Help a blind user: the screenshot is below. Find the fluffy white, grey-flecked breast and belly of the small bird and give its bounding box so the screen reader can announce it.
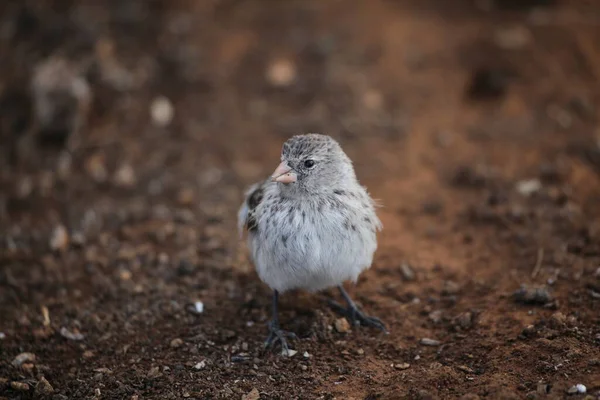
[249,188,379,292]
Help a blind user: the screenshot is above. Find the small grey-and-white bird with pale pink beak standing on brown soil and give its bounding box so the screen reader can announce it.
[238,133,388,354]
